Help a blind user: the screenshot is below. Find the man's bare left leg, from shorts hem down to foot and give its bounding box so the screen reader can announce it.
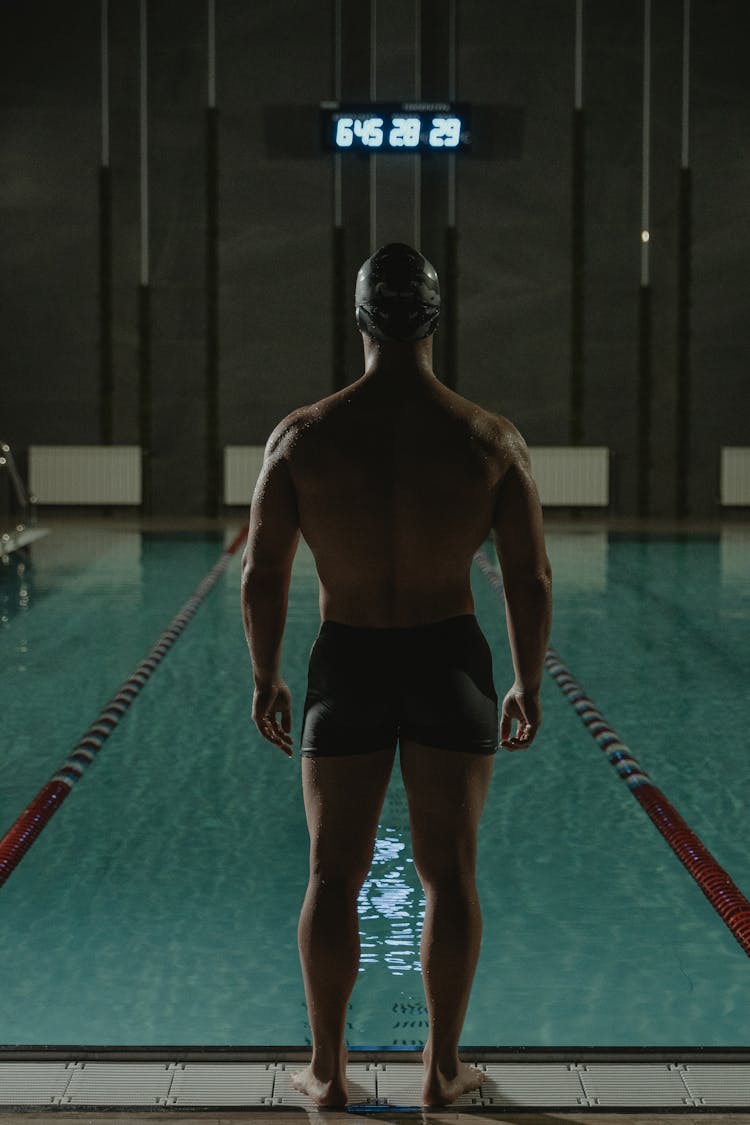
[292,749,396,1106]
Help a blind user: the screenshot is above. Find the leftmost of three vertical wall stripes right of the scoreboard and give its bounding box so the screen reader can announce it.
[568,0,586,446]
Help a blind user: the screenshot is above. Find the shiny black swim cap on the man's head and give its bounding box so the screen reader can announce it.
[354,242,440,343]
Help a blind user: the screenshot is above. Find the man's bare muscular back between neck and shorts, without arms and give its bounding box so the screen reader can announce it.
[269,372,523,627]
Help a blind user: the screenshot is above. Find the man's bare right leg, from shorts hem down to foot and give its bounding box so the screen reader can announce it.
[401,743,494,1106]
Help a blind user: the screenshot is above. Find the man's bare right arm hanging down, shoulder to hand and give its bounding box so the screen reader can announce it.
[493,431,552,750]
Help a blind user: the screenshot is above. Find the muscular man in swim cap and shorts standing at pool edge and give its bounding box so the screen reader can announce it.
[242,243,551,1107]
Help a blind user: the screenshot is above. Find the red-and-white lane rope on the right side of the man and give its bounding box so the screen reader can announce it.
[475,548,750,956]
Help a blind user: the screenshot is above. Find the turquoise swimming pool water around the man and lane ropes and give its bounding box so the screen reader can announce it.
[0,528,750,1046]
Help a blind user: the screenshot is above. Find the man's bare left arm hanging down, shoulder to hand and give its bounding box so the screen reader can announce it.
[242,438,299,757]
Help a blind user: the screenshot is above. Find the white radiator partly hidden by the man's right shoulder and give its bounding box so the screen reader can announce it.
[528,446,609,507]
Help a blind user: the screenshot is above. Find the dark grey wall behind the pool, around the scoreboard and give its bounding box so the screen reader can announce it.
[0,0,750,515]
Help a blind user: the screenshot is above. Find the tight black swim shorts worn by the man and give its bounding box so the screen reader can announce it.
[301,613,498,757]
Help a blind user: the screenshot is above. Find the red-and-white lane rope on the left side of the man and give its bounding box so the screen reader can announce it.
[0,527,247,887]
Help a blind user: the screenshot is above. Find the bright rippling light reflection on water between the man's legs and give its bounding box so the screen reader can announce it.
[359,826,424,977]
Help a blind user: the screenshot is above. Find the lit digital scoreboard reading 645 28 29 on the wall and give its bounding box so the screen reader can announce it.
[320,101,471,153]
